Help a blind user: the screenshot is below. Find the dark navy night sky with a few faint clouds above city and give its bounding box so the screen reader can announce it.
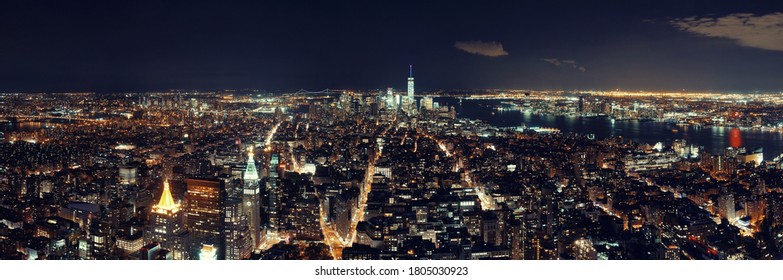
[0,0,783,92]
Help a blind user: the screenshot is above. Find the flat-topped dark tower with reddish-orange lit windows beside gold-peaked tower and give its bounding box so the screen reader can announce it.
[185,179,226,259]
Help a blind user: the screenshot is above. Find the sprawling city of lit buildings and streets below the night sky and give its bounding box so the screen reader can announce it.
[0,65,783,260]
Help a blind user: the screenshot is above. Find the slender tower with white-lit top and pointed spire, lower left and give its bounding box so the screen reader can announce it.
[242,147,261,248]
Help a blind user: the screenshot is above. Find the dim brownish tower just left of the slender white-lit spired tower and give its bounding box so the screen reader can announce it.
[224,198,254,260]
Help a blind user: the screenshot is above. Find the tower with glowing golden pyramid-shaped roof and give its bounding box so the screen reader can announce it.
[144,180,190,260]
